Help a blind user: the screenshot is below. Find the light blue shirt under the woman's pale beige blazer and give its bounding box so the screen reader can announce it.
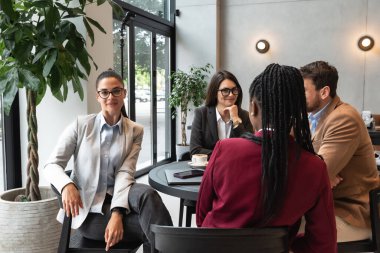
[90,113,123,213]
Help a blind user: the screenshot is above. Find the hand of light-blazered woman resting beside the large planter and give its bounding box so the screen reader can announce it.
[62,183,83,217]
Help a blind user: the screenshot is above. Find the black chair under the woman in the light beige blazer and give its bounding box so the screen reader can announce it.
[51,171,141,253]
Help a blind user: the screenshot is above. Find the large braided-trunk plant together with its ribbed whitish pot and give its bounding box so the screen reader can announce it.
[0,0,121,252]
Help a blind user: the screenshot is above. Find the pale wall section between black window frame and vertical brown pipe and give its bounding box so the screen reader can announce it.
[176,0,220,143]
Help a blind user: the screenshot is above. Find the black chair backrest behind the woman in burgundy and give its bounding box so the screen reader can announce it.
[151,225,289,253]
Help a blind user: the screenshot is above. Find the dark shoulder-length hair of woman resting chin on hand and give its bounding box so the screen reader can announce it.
[205,70,243,108]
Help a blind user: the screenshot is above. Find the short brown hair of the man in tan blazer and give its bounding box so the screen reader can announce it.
[300,61,339,98]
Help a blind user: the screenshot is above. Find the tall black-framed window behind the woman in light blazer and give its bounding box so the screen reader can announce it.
[113,1,175,176]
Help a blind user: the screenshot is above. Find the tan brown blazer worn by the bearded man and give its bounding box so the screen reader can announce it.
[312,96,379,228]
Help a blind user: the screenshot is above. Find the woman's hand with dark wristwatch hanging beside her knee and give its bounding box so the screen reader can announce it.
[104,212,124,251]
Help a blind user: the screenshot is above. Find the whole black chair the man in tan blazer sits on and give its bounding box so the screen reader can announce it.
[338,188,380,253]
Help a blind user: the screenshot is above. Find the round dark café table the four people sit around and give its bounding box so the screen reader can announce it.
[149,161,199,227]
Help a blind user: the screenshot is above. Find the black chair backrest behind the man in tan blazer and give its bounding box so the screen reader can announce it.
[369,187,380,251]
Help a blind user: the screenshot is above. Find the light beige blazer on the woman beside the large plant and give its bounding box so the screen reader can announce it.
[42,114,143,229]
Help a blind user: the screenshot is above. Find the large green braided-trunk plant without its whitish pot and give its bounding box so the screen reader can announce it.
[0,0,121,200]
